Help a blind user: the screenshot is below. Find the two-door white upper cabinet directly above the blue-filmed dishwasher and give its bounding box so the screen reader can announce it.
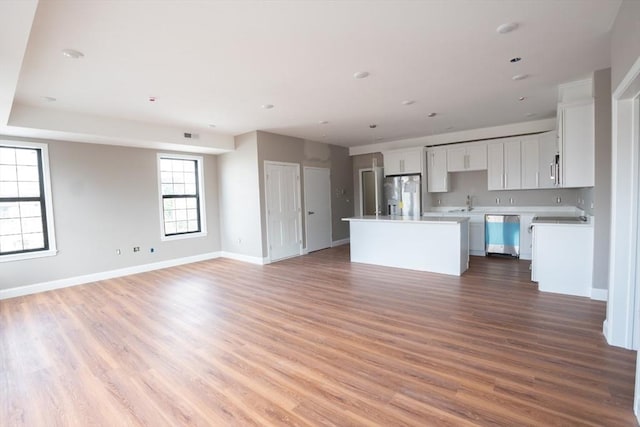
[487,139,522,190]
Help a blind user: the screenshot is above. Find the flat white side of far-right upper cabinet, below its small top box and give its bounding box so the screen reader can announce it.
[561,102,595,187]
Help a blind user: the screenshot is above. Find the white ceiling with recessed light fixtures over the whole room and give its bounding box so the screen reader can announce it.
[0,0,620,153]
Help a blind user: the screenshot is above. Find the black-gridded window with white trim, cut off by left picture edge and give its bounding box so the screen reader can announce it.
[0,141,56,261]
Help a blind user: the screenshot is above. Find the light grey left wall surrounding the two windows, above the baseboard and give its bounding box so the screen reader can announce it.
[0,138,220,290]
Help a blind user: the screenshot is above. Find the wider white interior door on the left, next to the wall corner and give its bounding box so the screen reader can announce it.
[264,162,302,261]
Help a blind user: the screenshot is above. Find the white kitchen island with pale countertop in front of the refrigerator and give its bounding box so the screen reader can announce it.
[343,215,469,276]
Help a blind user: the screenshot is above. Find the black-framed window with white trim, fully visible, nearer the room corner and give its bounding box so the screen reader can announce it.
[158,154,206,240]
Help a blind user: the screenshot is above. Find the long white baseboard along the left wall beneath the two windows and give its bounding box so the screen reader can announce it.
[0,252,220,300]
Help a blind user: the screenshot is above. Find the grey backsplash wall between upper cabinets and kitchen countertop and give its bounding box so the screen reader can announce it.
[423,171,593,213]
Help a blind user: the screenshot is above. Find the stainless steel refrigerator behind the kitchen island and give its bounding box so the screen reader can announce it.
[384,174,422,217]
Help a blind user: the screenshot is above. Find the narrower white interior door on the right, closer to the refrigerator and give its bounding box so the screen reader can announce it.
[304,167,331,252]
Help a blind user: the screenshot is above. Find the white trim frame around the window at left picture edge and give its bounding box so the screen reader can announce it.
[0,138,58,262]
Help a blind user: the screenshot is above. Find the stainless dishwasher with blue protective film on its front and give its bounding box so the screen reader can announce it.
[484,214,520,258]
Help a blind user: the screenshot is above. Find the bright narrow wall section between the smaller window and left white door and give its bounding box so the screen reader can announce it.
[218,132,266,261]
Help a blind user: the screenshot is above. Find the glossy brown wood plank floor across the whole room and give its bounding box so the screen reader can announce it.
[0,246,636,426]
